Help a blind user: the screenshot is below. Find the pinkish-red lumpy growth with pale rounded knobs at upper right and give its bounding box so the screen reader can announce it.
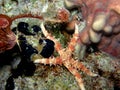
[65,0,120,57]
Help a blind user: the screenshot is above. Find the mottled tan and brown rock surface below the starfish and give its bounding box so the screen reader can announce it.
[0,53,120,90]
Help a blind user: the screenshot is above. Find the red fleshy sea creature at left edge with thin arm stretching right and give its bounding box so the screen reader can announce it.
[0,14,43,53]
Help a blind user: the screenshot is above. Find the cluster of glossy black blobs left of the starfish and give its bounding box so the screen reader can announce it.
[3,22,54,90]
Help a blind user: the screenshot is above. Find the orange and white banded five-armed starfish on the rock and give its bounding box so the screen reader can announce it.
[34,23,97,90]
